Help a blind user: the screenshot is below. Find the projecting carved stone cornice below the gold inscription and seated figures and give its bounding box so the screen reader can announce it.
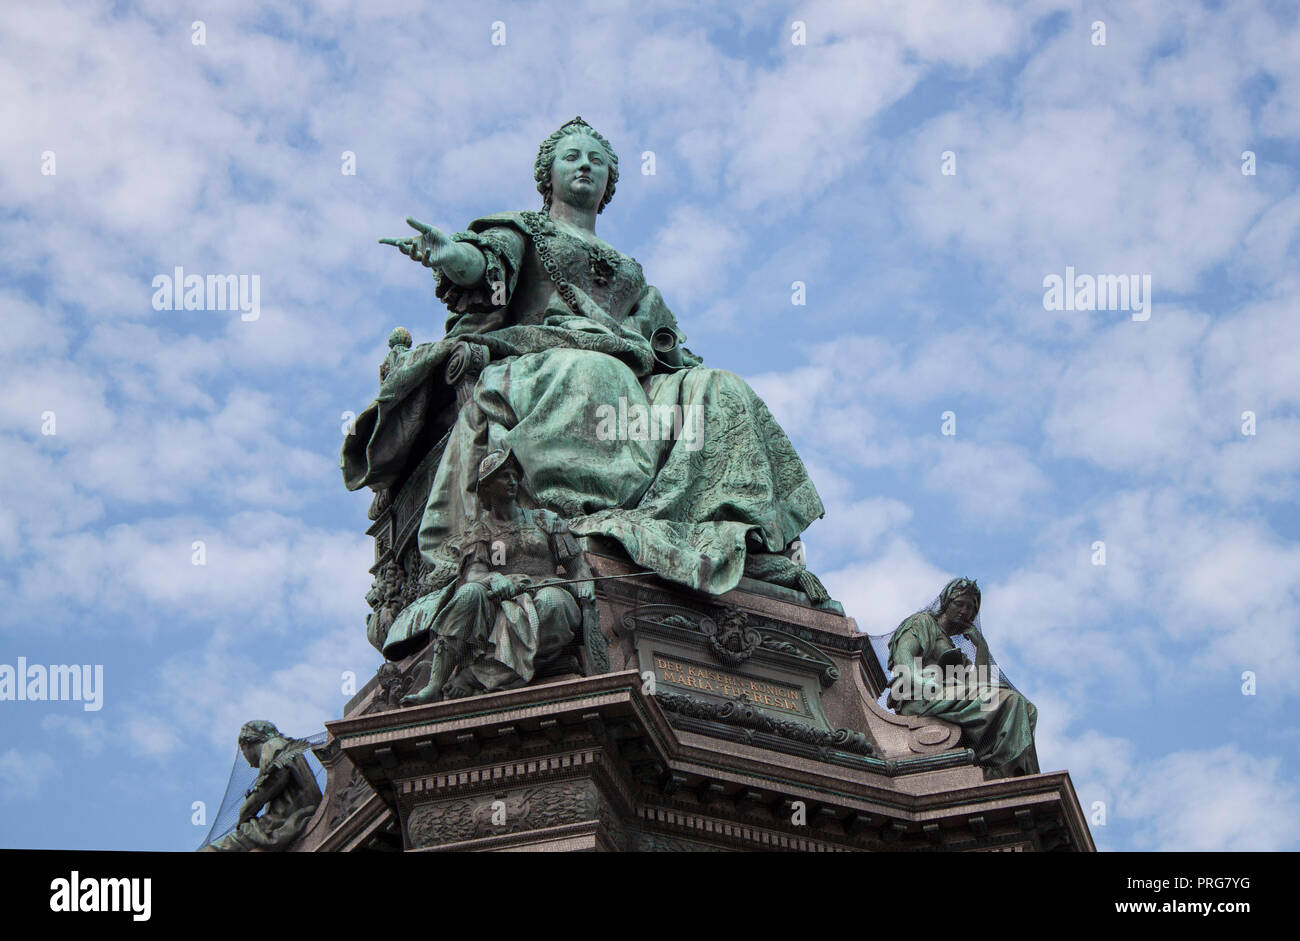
[309,671,1092,851]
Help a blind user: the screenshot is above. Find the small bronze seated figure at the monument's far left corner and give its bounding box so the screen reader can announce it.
[202,719,321,853]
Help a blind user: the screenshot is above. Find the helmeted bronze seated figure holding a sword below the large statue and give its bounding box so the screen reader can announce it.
[382,451,605,706]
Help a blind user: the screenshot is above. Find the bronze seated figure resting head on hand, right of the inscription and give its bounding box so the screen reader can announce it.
[889,578,1039,777]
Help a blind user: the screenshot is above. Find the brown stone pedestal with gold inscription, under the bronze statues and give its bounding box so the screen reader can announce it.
[289,546,1095,851]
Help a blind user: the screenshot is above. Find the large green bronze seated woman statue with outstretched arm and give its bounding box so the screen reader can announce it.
[342,118,827,602]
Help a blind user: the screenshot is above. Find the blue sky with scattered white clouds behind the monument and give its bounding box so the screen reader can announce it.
[0,0,1300,850]
